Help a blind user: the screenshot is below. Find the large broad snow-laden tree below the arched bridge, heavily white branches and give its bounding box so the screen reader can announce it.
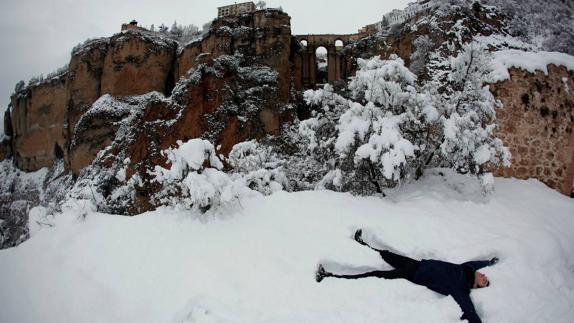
[300,56,438,194]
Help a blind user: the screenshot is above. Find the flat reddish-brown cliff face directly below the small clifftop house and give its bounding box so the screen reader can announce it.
[101,31,177,96]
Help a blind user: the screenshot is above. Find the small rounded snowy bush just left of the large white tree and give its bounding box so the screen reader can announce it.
[228,140,289,195]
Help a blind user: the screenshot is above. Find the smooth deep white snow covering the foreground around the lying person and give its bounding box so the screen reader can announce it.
[0,170,574,323]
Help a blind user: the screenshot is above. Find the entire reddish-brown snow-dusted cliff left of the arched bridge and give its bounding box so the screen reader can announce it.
[0,10,298,247]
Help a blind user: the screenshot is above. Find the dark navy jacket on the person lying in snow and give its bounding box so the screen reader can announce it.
[413,260,490,323]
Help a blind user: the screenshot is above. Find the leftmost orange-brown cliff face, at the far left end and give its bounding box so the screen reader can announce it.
[11,74,68,171]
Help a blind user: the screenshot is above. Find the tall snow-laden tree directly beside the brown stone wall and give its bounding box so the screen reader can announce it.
[431,43,510,191]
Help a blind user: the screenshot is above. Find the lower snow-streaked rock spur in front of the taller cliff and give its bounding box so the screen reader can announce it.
[80,54,294,214]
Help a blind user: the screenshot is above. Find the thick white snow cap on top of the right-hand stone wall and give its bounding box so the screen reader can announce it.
[492,49,574,83]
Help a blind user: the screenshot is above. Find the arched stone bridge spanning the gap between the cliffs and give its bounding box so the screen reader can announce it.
[295,35,358,88]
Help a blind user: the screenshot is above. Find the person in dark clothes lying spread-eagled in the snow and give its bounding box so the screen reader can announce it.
[316,229,498,323]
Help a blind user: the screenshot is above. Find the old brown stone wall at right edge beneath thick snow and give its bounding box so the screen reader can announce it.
[491,65,574,195]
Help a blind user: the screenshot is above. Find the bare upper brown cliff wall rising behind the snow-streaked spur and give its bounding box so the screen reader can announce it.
[7,10,300,175]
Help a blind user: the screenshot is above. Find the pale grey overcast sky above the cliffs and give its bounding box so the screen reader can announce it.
[0,0,410,133]
